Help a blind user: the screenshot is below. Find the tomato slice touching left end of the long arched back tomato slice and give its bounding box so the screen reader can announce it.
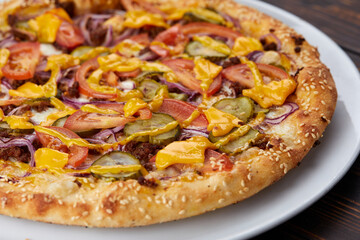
[150,24,189,57]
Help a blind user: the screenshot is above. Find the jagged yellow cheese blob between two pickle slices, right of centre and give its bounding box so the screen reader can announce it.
[204,107,241,137]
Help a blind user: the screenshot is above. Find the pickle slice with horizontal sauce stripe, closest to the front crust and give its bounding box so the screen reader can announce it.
[90,151,140,180]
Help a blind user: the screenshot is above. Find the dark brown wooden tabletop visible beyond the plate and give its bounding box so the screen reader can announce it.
[254,0,360,240]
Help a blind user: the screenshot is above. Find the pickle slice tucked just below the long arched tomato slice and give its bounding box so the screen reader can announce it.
[185,41,227,61]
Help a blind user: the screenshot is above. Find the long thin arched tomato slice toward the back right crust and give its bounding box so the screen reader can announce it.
[181,22,242,41]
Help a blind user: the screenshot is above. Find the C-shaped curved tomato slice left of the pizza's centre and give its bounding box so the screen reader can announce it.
[75,58,117,99]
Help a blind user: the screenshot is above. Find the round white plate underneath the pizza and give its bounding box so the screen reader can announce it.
[0,0,360,240]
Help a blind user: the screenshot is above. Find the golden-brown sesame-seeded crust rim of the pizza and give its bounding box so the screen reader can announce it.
[0,0,337,227]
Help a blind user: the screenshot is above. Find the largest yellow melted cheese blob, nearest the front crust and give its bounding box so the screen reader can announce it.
[155,136,215,170]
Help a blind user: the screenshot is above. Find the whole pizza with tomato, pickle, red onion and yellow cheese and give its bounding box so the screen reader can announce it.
[0,0,337,227]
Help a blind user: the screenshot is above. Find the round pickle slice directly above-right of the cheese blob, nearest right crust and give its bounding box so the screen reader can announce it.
[213,97,255,123]
